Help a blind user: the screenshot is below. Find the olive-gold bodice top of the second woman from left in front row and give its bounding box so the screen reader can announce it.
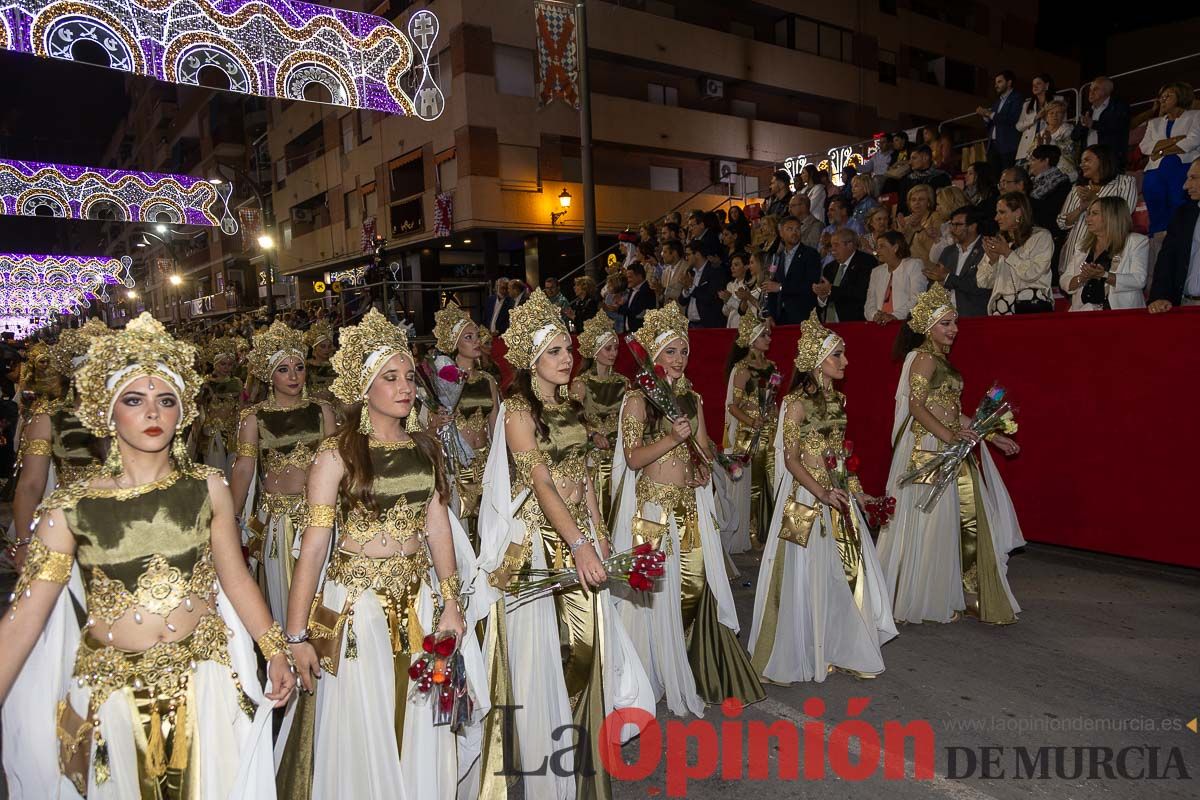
[320,437,437,545]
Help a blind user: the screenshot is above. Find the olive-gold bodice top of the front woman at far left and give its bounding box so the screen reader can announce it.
[44,467,216,625]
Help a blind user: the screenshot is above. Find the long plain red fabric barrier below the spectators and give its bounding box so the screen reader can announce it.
[494,308,1200,567]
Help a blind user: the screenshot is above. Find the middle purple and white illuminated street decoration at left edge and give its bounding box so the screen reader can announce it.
[0,158,238,235]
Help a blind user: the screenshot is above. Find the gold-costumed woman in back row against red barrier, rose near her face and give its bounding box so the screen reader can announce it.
[725,311,782,553]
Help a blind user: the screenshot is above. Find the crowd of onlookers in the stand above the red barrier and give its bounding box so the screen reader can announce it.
[481,72,1200,333]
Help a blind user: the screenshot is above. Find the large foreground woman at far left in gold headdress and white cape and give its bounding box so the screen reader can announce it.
[0,314,295,800]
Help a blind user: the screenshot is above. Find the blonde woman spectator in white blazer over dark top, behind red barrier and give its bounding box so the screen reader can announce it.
[1058,197,1150,311]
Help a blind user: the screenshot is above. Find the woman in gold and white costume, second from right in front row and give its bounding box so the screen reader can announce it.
[750,312,896,684]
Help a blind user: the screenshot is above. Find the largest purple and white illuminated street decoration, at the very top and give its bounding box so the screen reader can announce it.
[0,0,445,119]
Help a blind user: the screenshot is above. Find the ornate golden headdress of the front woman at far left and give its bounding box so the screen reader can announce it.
[76,312,200,437]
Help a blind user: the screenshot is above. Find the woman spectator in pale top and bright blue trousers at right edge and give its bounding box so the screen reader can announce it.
[1130,83,1200,236]
